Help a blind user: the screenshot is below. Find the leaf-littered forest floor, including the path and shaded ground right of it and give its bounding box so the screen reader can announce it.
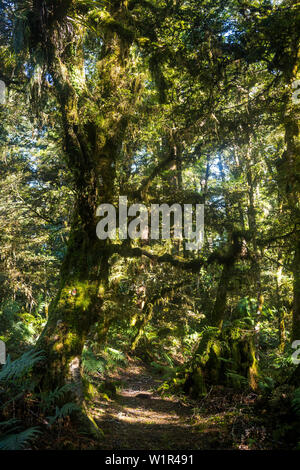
[91,361,270,450]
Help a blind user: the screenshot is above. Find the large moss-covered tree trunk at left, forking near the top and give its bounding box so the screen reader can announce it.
[28,4,130,395]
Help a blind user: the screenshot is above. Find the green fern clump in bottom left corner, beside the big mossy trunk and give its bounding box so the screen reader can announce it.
[0,350,80,450]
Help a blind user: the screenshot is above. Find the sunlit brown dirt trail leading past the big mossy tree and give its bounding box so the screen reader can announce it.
[92,363,244,450]
